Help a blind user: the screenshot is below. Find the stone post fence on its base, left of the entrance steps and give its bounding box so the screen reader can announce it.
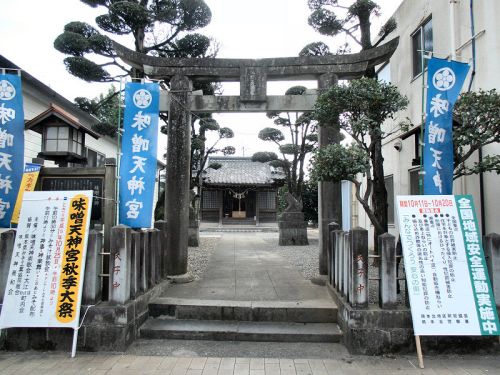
[0,221,169,351]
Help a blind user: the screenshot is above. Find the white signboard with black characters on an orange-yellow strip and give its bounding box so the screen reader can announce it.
[0,190,92,329]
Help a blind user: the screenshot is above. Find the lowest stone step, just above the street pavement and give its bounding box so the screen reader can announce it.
[139,318,342,342]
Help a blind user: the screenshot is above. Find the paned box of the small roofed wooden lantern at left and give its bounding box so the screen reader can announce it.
[44,126,83,155]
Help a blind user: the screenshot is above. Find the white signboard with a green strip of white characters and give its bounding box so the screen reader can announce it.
[397,195,500,336]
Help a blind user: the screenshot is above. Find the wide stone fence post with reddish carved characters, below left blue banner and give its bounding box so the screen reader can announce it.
[109,225,132,304]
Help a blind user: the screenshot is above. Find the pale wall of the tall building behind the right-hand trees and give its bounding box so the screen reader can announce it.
[358,0,500,245]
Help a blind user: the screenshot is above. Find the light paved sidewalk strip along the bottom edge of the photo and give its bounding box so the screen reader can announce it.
[0,352,500,375]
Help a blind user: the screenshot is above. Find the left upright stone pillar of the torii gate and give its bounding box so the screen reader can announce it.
[165,75,192,276]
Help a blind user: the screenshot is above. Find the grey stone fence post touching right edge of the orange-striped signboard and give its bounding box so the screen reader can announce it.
[82,229,103,305]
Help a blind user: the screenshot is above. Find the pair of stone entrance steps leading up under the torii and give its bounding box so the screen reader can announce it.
[140,298,342,342]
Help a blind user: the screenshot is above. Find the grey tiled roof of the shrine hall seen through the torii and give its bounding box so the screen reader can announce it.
[203,157,285,186]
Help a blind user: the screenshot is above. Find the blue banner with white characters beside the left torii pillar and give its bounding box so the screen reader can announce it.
[119,83,160,228]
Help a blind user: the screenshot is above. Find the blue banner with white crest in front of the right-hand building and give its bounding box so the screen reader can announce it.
[423,58,469,195]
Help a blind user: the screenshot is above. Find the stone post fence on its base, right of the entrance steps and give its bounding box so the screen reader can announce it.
[327,223,500,354]
